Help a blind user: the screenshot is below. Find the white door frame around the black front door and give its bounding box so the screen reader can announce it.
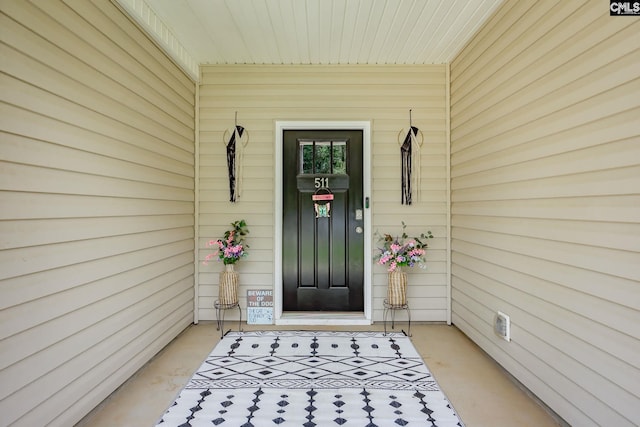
[273,121,373,325]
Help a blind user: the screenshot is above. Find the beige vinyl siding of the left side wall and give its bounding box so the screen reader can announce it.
[0,0,195,426]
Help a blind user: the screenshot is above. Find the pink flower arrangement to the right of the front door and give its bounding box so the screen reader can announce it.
[376,222,433,271]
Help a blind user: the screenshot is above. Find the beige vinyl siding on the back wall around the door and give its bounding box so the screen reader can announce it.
[199,65,447,321]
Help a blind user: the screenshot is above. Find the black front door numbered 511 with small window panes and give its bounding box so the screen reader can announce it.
[282,130,364,311]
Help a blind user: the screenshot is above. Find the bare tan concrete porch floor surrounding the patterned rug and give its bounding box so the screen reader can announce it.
[77,321,560,427]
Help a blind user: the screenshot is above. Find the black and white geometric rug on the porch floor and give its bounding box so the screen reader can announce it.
[157,331,463,427]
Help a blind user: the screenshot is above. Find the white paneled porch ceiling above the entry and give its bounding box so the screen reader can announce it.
[115,0,503,79]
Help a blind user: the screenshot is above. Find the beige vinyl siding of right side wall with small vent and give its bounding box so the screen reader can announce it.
[451,1,640,426]
